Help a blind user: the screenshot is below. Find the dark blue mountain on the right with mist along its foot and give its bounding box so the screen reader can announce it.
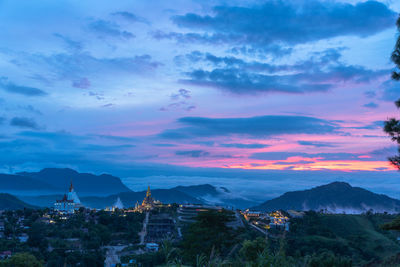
[252,182,400,213]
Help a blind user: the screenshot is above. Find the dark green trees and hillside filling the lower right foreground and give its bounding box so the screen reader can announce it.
[123,211,400,267]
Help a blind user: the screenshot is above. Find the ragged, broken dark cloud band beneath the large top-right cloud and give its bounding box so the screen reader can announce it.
[175,49,388,95]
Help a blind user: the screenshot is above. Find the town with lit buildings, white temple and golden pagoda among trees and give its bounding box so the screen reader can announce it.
[0,182,293,266]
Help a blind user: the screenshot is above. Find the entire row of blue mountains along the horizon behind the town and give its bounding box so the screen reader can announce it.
[0,168,400,213]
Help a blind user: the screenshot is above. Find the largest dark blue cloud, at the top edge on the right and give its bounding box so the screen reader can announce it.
[166,0,396,48]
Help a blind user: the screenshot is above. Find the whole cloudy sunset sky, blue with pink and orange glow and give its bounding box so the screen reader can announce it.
[0,0,400,200]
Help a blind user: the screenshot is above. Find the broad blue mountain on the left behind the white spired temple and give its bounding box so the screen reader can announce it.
[16,168,131,195]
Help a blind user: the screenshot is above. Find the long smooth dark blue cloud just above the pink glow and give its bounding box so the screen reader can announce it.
[160,115,339,139]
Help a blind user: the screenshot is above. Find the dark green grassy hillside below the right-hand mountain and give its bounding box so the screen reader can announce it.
[287,212,400,266]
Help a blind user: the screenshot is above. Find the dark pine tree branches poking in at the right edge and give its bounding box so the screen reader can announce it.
[384,16,400,170]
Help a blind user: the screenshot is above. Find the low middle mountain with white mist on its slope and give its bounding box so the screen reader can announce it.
[172,184,257,209]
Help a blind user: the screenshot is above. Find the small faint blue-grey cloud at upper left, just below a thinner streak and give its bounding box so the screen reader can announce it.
[89,19,135,39]
